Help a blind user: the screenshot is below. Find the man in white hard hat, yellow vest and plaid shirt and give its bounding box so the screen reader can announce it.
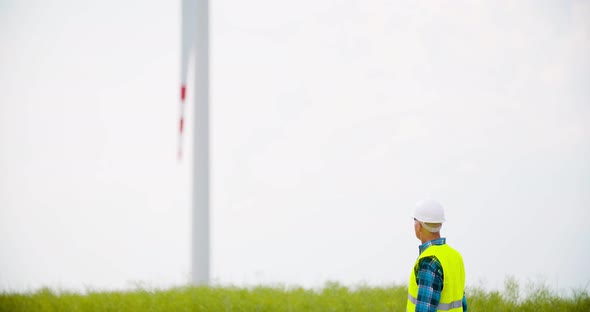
[406,200,467,312]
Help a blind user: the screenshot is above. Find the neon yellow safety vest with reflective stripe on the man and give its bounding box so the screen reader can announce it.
[406,244,465,312]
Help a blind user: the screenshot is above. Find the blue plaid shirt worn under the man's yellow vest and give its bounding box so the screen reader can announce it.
[414,237,467,312]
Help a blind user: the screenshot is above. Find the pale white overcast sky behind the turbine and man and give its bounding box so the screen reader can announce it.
[0,0,590,290]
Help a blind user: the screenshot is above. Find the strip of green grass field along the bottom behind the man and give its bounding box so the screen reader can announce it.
[0,280,590,312]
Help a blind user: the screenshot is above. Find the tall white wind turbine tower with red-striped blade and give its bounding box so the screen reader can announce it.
[178,0,210,285]
